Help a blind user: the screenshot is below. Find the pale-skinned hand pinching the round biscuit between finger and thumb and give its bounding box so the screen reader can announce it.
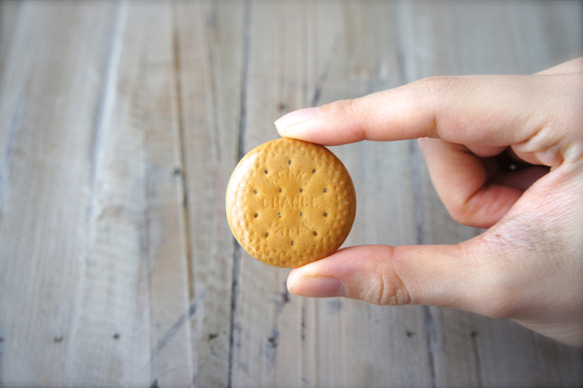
[276,57,583,347]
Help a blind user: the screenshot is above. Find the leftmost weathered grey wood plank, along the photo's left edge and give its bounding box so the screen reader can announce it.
[0,2,130,385]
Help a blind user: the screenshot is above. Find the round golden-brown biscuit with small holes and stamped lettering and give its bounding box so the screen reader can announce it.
[226,138,356,267]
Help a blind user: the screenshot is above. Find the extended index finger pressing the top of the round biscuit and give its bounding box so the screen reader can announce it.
[275,75,560,146]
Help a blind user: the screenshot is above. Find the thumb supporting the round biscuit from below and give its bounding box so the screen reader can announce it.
[287,242,505,317]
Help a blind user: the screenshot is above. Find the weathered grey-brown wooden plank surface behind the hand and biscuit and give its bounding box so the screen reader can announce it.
[0,0,583,387]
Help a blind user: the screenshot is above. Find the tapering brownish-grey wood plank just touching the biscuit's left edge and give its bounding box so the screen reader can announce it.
[173,1,247,387]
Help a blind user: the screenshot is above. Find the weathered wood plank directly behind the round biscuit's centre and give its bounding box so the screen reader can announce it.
[231,1,311,386]
